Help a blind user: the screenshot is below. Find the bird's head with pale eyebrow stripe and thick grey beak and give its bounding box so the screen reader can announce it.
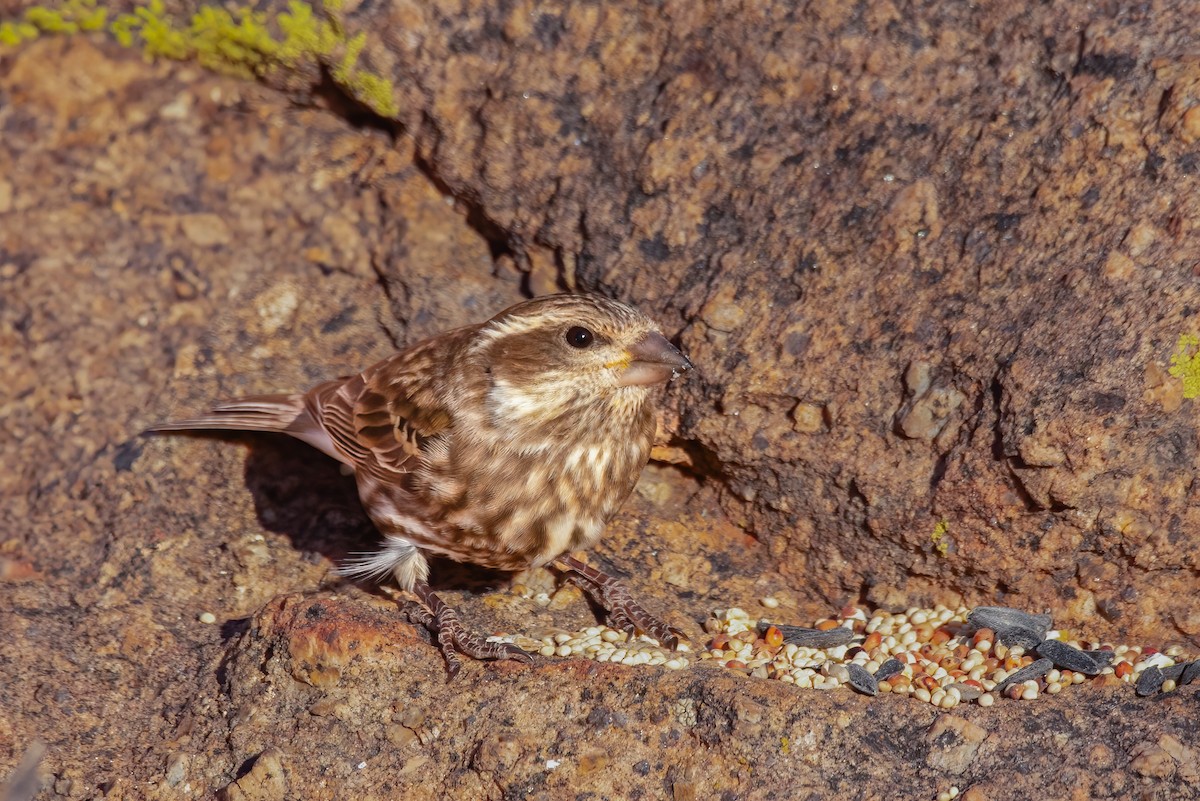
[473,295,692,428]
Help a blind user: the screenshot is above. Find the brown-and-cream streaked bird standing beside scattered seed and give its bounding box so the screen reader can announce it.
[148,293,694,679]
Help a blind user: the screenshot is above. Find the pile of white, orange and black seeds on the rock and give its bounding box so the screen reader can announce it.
[493,598,1200,709]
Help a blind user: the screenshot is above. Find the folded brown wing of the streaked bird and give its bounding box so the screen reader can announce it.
[305,326,479,481]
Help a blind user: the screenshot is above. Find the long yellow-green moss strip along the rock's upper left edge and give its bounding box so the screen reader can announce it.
[0,0,400,116]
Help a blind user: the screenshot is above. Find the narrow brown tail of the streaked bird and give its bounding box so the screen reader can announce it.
[146,395,349,464]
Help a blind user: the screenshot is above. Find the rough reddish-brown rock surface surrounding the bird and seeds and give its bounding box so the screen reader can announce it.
[0,0,1200,801]
